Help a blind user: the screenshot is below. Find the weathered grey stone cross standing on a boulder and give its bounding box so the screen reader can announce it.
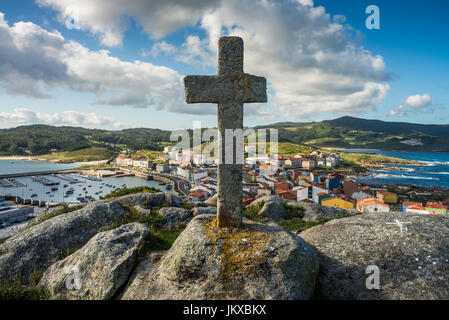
[184,37,267,227]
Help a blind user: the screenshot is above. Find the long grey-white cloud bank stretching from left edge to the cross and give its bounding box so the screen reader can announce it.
[0,13,194,112]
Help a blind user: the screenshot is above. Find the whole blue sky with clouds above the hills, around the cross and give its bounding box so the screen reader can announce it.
[0,0,449,129]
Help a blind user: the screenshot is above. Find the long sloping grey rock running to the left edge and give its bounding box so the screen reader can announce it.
[0,201,126,283]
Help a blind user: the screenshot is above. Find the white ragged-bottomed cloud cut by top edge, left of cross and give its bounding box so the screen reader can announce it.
[36,0,220,46]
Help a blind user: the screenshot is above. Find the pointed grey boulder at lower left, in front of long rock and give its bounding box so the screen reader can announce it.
[39,223,150,300]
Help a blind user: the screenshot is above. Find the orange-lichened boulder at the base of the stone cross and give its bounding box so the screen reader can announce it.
[122,215,318,300]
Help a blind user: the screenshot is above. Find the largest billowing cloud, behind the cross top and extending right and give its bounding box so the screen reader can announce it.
[177,0,390,119]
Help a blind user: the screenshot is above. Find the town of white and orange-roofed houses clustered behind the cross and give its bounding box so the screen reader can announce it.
[116,146,449,214]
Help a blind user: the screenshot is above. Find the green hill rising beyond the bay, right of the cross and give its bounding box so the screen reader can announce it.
[260,117,449,152]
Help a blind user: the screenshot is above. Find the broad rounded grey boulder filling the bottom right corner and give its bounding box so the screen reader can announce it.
[299,213,449,299]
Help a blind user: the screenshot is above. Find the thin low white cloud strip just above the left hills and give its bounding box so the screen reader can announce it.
[0,108,126,129]
